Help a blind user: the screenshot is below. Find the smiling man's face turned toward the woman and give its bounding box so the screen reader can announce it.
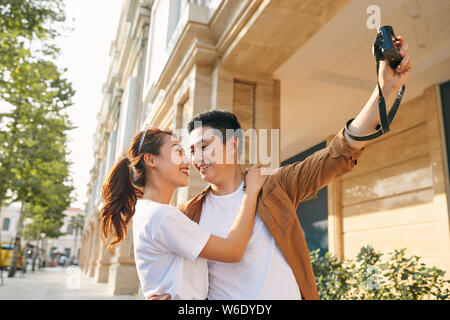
[190,126,236,183]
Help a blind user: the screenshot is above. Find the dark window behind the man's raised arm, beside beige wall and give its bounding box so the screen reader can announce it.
[281,142,328,255]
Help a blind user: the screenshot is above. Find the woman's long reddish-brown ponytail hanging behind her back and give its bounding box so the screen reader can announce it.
[100,158,142,251]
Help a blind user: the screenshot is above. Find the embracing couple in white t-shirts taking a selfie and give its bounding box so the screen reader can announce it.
[101,37,411,300]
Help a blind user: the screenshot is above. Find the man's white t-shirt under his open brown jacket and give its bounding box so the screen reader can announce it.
[200,183,301,300]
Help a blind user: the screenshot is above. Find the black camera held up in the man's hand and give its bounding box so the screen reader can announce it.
[373,26,402,70]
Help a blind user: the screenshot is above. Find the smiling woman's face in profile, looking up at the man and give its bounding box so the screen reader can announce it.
[154,135,190,188]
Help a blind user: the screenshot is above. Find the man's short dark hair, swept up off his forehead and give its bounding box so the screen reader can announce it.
[187,110,242,156]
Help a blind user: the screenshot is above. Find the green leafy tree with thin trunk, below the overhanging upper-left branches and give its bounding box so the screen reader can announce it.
[6,74,73,276]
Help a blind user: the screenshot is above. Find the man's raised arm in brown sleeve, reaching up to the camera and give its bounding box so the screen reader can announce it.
[271,37,412,206]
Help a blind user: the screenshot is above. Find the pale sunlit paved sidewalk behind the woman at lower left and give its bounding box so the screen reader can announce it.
[0,266,143,300]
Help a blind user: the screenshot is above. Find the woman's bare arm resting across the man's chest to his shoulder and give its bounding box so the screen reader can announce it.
[199,166,267,262]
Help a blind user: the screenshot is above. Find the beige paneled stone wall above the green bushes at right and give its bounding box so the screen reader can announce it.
[330,86,450,271]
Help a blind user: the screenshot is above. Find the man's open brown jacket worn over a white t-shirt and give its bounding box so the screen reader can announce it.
[179,128,364,300]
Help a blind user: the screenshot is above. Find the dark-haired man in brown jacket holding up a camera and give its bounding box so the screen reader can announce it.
[154,37,412,300]
